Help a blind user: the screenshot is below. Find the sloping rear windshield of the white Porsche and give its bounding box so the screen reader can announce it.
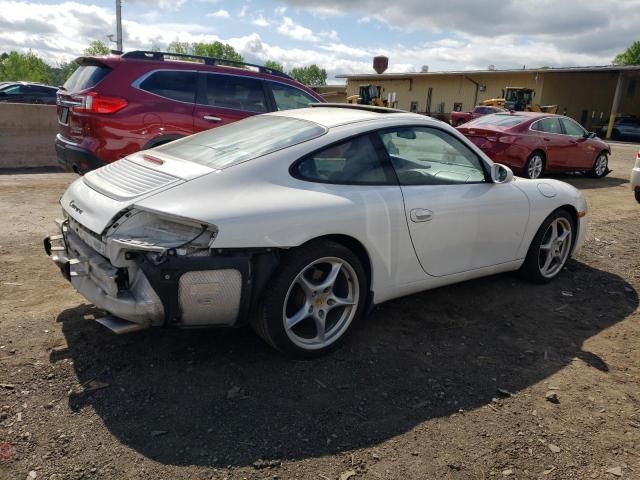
[155,115,326,170]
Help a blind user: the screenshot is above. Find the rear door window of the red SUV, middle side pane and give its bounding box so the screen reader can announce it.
[204,73,267,113]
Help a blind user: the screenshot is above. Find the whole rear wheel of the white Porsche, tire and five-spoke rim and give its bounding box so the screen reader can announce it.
[254,241,368,358]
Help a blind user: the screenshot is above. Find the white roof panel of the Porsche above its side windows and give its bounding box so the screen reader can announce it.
[265,103,439,128]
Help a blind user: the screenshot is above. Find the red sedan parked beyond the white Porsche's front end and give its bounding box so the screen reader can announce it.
[458,112,611,178]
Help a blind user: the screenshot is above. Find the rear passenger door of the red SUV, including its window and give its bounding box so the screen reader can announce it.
[193,72,268,132]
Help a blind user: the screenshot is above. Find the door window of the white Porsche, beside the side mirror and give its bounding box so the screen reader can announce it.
[380,127,486,185]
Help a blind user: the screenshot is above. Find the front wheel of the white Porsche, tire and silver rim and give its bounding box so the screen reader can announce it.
[520,210,575,283]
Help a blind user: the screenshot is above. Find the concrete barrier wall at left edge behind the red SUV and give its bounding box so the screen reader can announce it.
[0,103,58,169]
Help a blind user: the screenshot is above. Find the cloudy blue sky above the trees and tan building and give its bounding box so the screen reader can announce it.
[0,0,640,81]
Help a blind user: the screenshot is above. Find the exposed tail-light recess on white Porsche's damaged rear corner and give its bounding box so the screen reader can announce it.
[106,210,217,252]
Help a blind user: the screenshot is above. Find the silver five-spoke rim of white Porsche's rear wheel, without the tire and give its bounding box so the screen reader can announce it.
[282,257,360,350]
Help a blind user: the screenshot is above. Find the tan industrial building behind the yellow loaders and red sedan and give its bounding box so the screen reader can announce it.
[338,65,640,137]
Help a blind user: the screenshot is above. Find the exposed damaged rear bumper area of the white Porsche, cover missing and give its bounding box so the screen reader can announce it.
[44,220,276,327]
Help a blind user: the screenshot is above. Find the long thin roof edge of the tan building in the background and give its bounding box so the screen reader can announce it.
[336,65,640,79]
